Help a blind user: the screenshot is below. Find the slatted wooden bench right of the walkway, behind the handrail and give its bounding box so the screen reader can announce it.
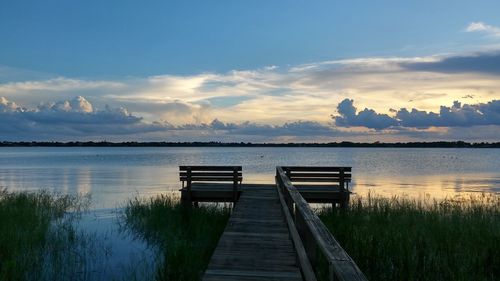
[281,166,352,206]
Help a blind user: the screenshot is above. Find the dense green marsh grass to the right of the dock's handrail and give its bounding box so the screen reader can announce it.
[318,194,500,280]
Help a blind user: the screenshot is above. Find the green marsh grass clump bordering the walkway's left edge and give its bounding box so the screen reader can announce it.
[124,194,230,280]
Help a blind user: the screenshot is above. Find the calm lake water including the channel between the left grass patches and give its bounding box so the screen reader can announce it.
[0,147,500,280]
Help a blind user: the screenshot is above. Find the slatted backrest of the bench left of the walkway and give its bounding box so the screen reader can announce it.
[179,166,243,183]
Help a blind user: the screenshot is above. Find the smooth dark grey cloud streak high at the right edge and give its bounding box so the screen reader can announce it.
[400,52,500,74]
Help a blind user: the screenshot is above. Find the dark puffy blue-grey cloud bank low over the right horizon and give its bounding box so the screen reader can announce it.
[333,99,500,130]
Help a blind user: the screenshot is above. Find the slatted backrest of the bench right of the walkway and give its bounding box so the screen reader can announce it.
[281,166,351,189]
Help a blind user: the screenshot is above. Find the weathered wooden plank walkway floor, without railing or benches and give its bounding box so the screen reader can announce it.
[203,184,302,281]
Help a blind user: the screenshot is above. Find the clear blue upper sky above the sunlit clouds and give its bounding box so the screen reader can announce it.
[0,0,500,78]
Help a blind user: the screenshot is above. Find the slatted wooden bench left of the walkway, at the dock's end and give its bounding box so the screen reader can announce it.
[179,166,243,205]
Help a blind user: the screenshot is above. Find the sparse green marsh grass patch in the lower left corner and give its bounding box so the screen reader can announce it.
[0,189,93,280]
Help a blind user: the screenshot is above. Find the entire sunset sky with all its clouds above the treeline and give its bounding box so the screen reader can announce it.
[0,0,500,142]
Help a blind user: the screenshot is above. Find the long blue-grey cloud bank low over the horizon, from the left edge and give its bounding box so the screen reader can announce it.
[0,96,344,139]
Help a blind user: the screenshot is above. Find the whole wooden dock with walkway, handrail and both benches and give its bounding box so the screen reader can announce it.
[179,166,367,281]
